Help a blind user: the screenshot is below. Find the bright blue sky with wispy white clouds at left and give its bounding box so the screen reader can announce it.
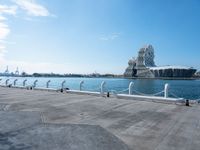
[0,0,200,74]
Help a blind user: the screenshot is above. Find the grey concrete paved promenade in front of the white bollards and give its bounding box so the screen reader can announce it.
[0,87,200,150]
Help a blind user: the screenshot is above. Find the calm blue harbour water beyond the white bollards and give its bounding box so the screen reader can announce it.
[0,77,200,100]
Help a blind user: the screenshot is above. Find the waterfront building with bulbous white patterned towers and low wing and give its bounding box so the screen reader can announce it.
[124,45,196,78]
